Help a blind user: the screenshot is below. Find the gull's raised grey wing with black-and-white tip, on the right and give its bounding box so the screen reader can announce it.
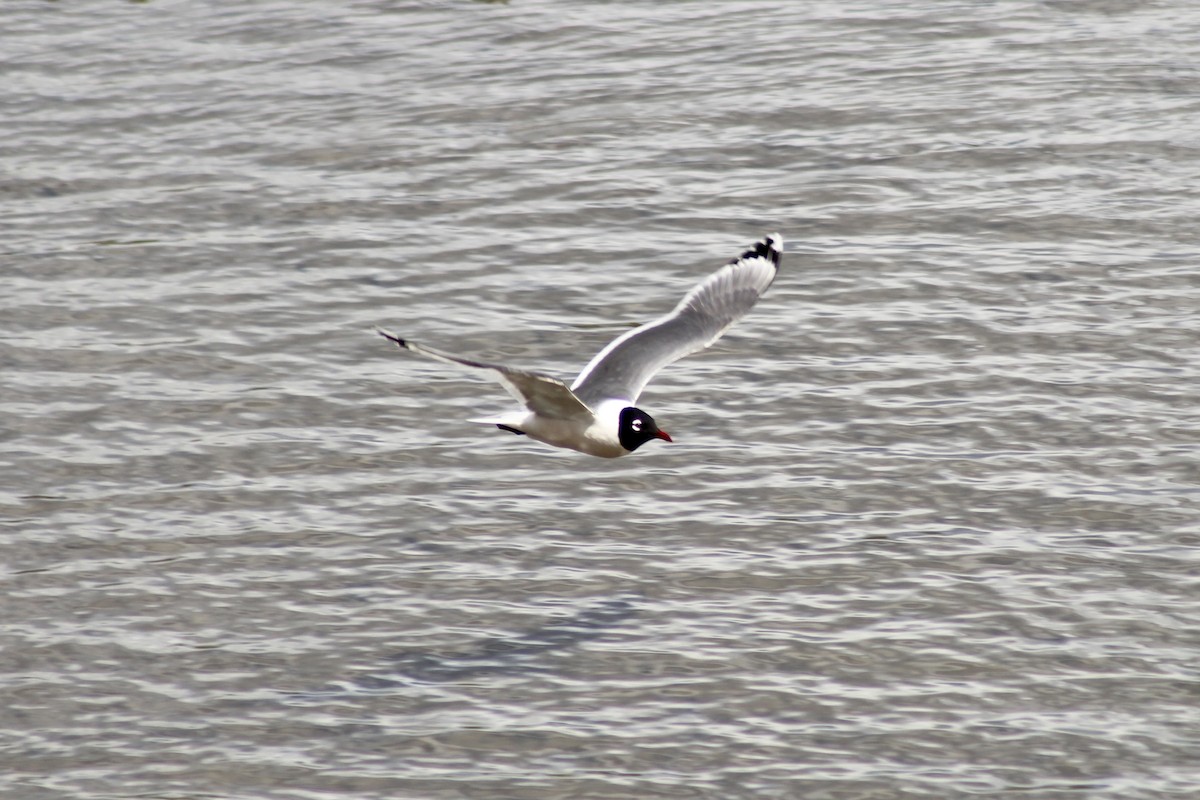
[571,234,784,407]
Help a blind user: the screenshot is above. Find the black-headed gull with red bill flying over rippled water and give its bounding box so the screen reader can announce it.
[377,234,784,458]
